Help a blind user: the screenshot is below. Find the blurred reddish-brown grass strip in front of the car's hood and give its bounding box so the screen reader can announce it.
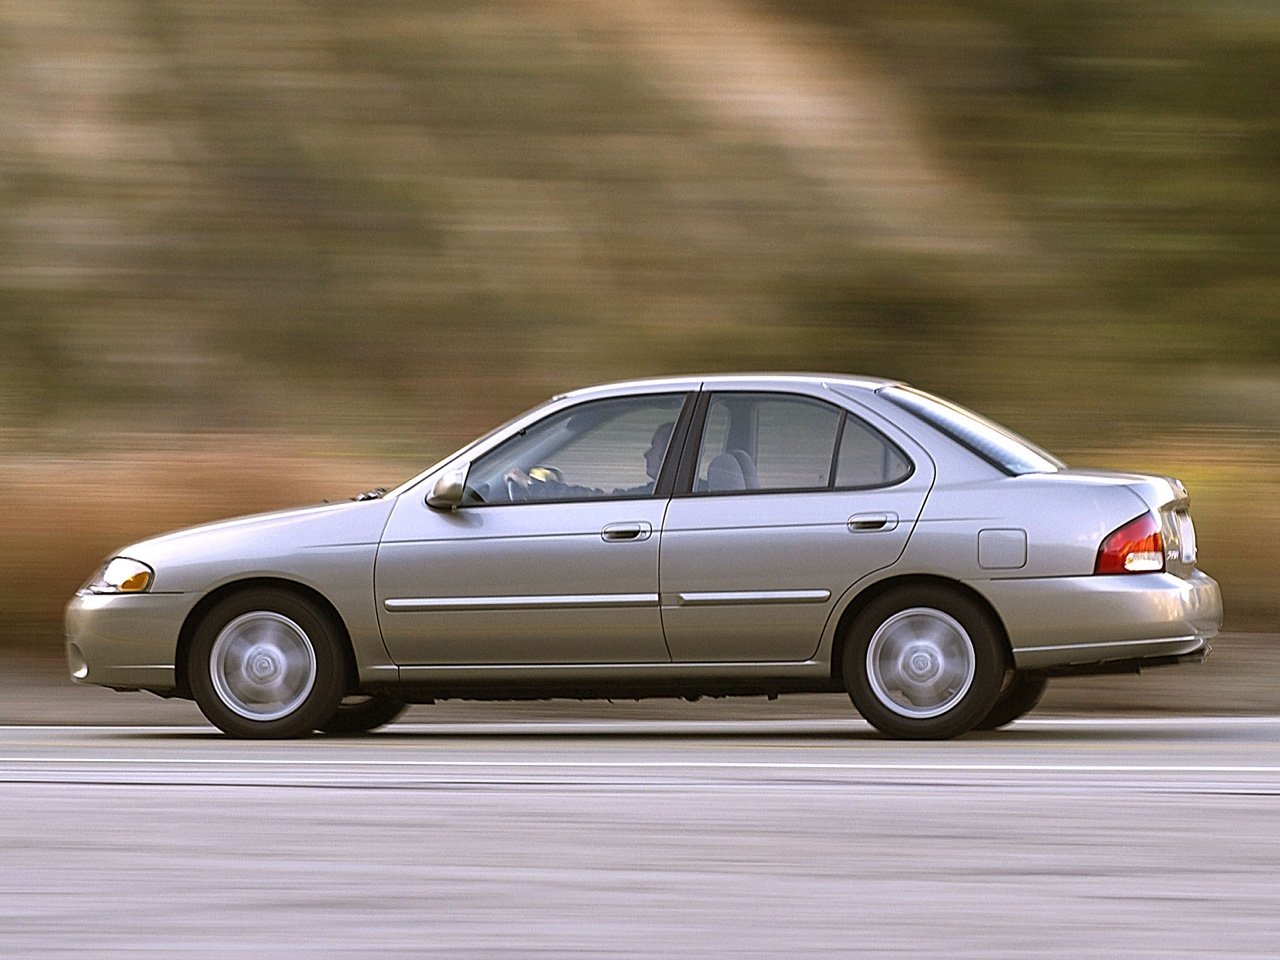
[0,434,412,649]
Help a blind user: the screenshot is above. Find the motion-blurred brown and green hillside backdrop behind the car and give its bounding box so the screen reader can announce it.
[0,0,1280,658]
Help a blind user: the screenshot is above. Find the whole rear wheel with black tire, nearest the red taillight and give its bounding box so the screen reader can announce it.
[841,586,1009,740]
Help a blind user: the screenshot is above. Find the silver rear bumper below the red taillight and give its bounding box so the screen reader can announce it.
[974,571,1222,669]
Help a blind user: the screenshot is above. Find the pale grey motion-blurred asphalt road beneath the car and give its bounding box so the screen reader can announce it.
[0,717,1280,960]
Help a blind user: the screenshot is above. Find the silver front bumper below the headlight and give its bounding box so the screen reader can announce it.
[65,593,196,692]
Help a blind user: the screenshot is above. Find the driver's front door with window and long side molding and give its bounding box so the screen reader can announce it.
[375,394,686,666]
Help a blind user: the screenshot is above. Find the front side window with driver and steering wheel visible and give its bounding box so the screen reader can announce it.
[463,394,685,504]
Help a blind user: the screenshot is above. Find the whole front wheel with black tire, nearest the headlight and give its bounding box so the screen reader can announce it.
[187,589,346,740]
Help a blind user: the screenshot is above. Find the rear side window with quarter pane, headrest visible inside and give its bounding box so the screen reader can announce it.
[694,393,913,494]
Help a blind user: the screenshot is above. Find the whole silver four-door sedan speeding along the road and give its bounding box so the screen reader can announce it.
[67,375,1222,739]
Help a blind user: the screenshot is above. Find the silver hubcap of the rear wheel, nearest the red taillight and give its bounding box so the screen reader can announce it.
[867,607,977,719]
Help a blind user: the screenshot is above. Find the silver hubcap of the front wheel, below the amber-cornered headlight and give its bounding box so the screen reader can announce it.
[209,611,316,721]
